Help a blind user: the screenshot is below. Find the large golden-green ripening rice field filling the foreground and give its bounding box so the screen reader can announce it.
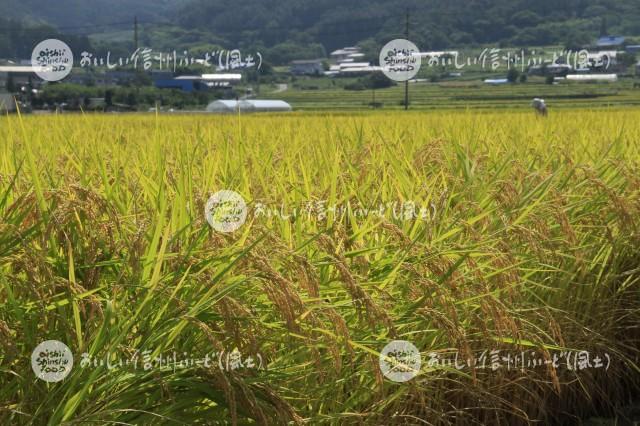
[0,109,640,425]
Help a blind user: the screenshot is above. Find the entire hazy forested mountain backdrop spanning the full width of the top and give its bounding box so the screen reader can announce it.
[0,0,640,64]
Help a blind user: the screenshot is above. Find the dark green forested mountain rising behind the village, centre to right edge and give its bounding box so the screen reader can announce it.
[179,0,640,49]
